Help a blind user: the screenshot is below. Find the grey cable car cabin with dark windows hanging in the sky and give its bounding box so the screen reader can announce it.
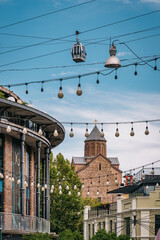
[71,43,87,62]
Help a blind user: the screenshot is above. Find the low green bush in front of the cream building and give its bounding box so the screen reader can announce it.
[91,229,118,240]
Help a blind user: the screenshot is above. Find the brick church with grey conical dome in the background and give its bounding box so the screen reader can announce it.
[72,125,122,203]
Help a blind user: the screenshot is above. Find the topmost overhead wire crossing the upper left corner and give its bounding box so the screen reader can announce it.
[0,0,96,29]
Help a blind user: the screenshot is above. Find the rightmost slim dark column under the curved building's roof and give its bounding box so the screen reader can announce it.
[45,148,49,220]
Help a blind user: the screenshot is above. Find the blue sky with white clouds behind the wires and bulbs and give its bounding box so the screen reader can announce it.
[0,0,160,171]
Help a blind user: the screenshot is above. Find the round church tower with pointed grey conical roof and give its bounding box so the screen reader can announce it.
[84,125,107,162]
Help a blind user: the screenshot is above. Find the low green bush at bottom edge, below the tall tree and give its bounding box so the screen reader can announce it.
[58,229,84,240]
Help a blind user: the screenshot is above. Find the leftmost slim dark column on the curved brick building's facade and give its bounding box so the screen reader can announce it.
[20,134,25,216]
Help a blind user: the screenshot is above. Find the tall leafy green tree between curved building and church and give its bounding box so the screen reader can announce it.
[50,153,83,233]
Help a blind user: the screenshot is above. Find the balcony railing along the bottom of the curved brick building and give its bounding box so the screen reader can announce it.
[0,212,50,233]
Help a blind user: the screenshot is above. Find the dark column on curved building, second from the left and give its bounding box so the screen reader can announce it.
[36,141,41,218]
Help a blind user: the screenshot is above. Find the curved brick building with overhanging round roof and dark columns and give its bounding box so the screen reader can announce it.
[0,87,65,240]
